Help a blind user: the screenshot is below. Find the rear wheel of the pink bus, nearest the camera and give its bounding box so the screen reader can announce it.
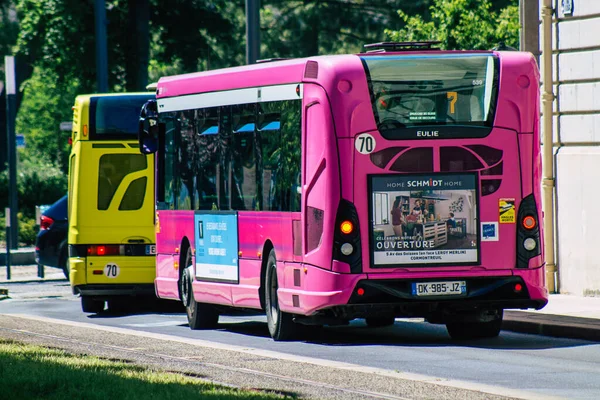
[265,250,296,341]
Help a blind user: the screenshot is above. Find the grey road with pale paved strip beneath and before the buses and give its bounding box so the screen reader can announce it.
[0,281,600,399]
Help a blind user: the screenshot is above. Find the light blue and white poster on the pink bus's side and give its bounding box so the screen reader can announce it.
[194,211,239,283]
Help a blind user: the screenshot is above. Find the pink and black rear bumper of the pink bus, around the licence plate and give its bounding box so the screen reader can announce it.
[278,264,548,320]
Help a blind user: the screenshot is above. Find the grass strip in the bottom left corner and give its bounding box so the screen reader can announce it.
[0,339,290,400]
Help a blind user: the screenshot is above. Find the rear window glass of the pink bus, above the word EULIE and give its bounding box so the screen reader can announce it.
[361,54,497,134]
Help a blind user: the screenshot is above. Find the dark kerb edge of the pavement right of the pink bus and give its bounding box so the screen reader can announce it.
[502,311,600,342]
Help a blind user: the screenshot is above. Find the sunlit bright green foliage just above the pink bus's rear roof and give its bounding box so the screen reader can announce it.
[386,0,519,50]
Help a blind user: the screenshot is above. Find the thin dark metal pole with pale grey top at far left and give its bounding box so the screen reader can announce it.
[4,56,19,249]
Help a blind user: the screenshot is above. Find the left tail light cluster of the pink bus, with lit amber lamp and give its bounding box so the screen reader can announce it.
[333,199,362,274]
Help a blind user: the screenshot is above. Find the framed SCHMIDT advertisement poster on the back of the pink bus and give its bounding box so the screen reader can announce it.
[370,174,479,267]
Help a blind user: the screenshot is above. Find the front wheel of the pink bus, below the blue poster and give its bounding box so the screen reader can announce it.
[181,248,219,330]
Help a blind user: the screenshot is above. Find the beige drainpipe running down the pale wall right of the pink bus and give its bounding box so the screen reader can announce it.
[542,0,558,293]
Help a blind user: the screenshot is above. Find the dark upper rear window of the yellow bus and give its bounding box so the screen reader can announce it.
[90,93,154,140]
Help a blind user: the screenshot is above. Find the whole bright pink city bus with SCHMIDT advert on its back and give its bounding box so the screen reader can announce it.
[140,43,548,340]
